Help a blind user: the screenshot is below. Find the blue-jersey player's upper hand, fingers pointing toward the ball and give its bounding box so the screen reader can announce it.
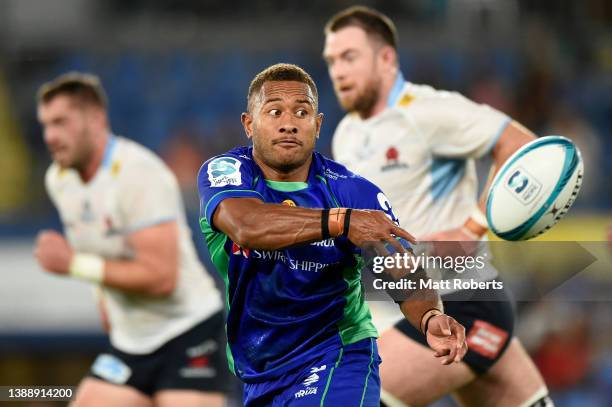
[348,209,416,253]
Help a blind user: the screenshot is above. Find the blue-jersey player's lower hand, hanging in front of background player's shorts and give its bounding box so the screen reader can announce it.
[426,314,467,365]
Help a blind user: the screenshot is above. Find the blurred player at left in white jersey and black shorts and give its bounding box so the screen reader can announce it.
[35,73,229,407]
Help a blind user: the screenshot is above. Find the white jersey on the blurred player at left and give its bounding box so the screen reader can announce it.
[45,136,223,354]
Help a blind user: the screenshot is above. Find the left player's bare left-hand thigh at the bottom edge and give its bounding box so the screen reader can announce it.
[70,377,153,407]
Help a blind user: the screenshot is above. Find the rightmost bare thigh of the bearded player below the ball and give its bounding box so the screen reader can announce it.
[455,338,552,407]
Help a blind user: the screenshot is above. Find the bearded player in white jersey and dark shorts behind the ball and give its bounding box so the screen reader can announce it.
[323,7,552,407]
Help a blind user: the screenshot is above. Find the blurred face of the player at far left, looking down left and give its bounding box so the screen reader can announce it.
[38,95,93,168]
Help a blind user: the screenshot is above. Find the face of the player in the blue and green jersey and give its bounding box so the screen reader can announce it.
[242,81,323,173]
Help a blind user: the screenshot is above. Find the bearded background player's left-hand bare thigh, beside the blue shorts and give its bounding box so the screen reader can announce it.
[378,327,476,407]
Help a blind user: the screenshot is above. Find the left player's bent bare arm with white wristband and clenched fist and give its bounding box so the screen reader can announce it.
[34,221,179,296]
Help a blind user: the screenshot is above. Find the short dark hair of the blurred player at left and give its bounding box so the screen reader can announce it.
[36,72,108,109]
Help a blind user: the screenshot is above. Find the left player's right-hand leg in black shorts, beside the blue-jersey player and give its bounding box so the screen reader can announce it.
[154,312,232,407]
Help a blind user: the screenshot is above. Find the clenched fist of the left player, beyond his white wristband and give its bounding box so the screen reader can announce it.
[34,230,74,274]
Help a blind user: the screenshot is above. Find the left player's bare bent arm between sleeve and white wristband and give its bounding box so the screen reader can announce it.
[103,221,179,296]
